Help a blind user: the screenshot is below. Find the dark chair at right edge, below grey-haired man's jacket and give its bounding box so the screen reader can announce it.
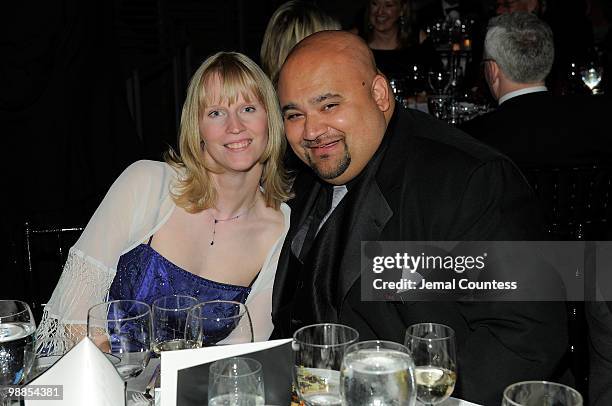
[523,165,612,402]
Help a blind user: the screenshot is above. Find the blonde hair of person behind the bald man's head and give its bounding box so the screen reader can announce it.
[260,0,342,84]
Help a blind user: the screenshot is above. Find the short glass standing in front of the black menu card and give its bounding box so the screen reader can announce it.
[208,357,265,406]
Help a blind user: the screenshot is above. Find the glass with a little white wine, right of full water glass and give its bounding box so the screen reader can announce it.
[405,323,457,405]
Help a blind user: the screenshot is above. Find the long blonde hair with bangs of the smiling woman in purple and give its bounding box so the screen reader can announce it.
[165,52,290,213]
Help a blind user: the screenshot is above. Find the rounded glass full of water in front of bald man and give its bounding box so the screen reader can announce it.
[340,341,416,406]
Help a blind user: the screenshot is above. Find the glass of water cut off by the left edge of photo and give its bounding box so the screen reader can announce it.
[0,300,36,404]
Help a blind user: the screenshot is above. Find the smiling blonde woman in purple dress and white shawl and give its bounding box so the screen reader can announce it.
[38,52,290,340]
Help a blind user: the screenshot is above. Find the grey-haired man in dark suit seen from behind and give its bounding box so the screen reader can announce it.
[462,12,610,168]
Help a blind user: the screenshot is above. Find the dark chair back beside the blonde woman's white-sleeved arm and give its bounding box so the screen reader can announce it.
[24,221,83,323]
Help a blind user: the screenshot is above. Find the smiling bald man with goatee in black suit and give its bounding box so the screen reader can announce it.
[273,31,567,405]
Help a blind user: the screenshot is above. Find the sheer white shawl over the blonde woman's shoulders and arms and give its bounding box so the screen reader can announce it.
[36,161,290,341]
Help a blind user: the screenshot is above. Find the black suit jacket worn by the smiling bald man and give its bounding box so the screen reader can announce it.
[272,109,567,405]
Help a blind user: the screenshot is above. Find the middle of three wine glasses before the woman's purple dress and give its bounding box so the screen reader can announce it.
[151,295,198,355]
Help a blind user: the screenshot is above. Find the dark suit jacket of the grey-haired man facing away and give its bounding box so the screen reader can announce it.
[461,92,612,169]
